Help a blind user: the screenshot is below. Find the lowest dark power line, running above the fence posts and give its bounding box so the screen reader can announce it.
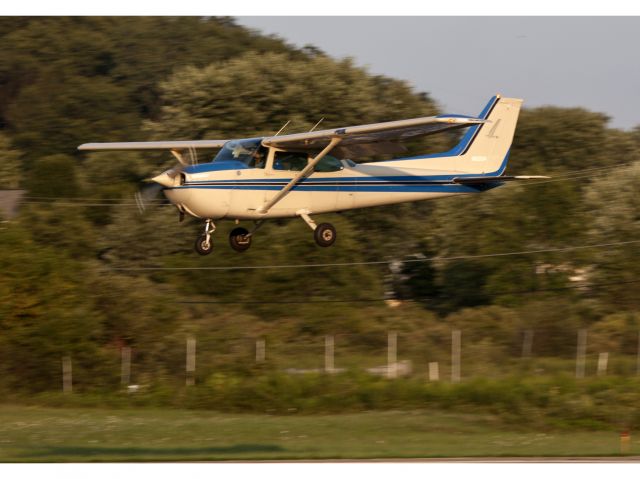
[175,279,640,304]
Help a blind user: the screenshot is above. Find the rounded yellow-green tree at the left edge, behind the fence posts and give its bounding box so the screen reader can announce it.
[0,226,103,390]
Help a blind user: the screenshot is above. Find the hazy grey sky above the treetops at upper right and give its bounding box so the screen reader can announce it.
[236,17,640,128]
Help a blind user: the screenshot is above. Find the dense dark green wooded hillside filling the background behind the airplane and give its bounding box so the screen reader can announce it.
[0,17,640,409]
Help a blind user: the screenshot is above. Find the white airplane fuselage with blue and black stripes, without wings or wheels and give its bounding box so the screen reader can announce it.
[164,154,497,220]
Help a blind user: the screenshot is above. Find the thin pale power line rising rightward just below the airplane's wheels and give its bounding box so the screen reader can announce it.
[111,240,640,271]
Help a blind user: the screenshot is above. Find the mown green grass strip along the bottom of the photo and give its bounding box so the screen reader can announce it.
[0,406,640,462]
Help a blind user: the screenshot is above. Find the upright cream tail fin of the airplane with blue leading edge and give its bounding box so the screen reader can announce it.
[452,96,522,175]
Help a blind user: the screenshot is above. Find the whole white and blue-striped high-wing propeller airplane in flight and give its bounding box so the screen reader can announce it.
[78,95,546,255]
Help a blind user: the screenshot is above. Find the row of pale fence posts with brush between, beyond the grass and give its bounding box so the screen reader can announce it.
[61,329,640,393]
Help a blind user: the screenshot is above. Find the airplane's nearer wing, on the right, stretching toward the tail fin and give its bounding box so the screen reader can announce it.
[262,115,486,158]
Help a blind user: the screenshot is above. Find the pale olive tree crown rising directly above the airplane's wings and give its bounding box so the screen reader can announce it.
[147,53,436,139]
